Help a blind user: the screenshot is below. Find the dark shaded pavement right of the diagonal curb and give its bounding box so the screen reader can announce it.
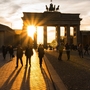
[46,50,90,90]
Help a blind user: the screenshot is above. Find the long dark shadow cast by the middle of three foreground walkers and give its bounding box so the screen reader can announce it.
[20,67,30,90]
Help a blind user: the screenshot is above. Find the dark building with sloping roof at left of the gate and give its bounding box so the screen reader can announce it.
[0,24,21,50]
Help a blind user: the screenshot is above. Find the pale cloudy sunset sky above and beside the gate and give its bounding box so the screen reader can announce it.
[0,0,90,30]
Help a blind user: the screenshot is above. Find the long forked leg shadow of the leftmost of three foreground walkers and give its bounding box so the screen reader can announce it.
[0,67,22,90]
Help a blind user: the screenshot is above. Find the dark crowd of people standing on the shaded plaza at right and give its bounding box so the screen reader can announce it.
[57,42,90,60]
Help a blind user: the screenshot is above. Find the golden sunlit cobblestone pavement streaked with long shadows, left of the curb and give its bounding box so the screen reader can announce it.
[0,51,54,90]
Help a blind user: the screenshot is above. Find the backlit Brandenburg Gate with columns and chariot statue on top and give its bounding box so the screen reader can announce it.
[22,2,82,48]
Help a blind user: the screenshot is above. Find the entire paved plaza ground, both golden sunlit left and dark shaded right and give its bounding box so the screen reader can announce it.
[0,50,90,90]
